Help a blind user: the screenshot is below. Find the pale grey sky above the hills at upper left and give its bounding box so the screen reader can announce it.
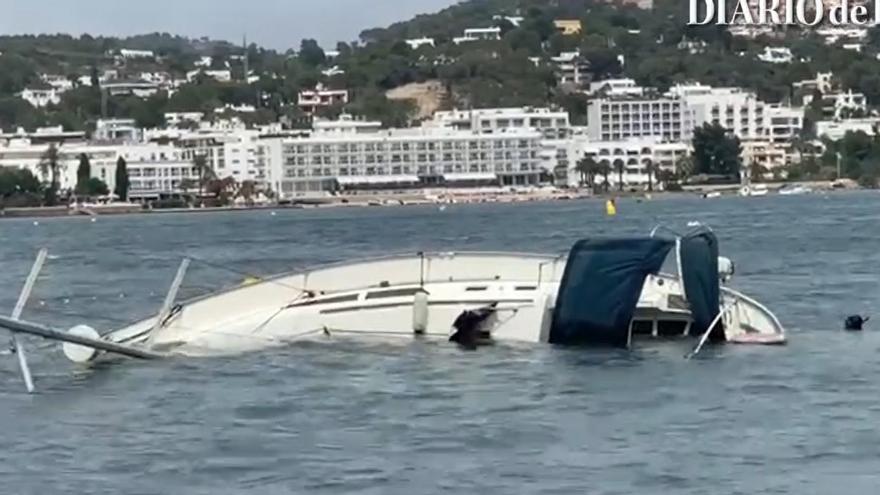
[0,0,457,50]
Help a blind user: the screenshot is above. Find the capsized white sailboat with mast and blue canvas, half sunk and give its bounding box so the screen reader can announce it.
[0,224,785,392]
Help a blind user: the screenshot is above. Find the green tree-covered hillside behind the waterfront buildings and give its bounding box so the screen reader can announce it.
[0,0,880,130]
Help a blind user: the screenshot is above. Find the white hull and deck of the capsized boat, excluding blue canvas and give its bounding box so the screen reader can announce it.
[108,253,784,355]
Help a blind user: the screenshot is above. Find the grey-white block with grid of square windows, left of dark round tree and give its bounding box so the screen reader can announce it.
[587,96,693,141]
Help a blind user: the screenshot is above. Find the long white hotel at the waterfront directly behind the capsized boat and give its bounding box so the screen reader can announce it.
[268,126,543,199]
